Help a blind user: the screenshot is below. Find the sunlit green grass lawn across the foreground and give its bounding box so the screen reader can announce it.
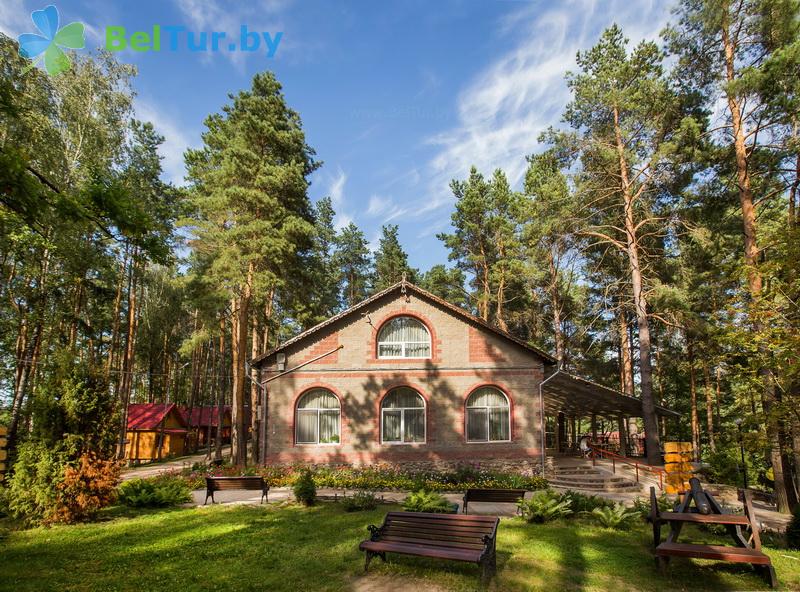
[0,503,800,592]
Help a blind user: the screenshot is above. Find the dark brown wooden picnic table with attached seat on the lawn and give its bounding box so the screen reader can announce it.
[649,477,778,588]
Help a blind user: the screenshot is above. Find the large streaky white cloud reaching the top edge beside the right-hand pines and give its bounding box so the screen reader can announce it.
[415,0,669,215]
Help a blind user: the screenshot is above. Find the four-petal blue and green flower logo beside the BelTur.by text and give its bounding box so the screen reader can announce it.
[17,5,86,76]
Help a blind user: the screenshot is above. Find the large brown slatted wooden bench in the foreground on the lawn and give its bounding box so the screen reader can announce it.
[358,512,500,581]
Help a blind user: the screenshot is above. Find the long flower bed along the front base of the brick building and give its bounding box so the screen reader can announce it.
[166,464,547,491]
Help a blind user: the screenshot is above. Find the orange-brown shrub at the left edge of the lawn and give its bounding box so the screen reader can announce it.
[46,453,120,524]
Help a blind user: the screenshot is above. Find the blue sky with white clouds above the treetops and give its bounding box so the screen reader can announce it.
[0,0,671,270]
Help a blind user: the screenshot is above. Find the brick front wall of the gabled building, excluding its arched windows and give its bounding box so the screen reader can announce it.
[263,292,543,466]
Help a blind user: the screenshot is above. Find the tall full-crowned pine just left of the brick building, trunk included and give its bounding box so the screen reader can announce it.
[186,72,317,464]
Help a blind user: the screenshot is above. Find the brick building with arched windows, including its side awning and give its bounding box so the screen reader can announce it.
[253,282,670,468]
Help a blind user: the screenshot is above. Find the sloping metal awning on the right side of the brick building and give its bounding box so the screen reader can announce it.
[542,370,680,418]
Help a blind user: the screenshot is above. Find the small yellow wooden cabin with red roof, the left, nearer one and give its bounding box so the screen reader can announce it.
[125,403,188,461]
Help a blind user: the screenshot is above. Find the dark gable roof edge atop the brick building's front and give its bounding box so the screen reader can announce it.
[250,280,556,366]
